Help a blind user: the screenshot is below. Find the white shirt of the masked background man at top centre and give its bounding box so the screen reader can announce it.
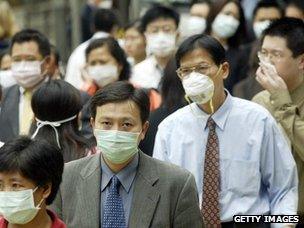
[130,55,163,89]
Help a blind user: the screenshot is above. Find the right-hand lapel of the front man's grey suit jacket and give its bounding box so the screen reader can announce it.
[129,152,160,227]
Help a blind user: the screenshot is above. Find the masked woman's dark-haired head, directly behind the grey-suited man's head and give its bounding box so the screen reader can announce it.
[85,37,130,87]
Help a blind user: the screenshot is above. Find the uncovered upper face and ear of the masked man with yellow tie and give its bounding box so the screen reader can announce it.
[11,41,49,72]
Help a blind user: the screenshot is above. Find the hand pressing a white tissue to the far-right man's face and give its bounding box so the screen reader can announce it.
[256,62,288,94]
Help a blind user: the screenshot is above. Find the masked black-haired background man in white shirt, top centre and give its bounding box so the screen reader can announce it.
[131,6,179,89]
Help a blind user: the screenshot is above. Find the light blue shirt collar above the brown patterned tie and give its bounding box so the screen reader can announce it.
[191,90,232,131]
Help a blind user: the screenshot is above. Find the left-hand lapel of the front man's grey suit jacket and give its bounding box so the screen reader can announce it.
[79,154,101,227]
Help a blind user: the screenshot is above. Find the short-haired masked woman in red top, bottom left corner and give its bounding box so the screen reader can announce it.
[0,137,66,228]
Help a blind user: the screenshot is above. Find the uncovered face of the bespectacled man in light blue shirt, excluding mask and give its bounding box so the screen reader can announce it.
[179,48,229,91]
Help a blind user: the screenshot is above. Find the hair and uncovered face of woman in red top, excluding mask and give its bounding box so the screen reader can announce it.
[0,137,64,207]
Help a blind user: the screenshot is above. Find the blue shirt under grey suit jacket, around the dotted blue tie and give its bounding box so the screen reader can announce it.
[100,154,138,224]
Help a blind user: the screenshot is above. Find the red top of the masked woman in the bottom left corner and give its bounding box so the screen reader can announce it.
[7,205,52,228]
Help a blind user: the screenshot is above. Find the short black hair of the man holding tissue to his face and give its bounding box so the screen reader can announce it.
[262,17,304,57]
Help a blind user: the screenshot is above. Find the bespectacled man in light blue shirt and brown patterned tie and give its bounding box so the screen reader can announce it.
[153,35,298,228]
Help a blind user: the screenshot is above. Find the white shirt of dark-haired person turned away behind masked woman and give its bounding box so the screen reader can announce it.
[65,32,109,89]
